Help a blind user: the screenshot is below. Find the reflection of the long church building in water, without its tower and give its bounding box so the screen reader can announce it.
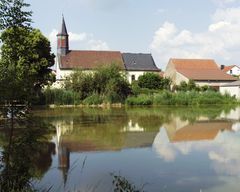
[54,120,157,153]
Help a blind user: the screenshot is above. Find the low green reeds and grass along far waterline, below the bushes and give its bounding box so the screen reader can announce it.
[45,89,239,106]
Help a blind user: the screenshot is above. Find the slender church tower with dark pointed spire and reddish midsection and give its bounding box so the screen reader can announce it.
[57,17,69,56]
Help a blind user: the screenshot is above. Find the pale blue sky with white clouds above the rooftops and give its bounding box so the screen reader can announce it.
[26,0,240,70]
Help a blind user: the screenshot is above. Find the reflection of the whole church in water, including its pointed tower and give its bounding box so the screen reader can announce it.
[53,120,157,183]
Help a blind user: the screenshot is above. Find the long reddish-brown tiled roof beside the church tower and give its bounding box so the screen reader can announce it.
[60,51,124,70]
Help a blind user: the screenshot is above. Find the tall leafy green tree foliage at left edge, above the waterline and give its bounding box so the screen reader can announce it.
[0,0,54,102]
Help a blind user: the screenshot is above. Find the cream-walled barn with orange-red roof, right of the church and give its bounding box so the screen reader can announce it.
[164,59,236,88]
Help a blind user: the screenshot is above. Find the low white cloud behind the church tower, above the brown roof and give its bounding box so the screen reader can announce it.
[48,29,109,51]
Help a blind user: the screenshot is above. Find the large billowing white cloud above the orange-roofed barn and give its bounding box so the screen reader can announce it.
[150,7,240,67]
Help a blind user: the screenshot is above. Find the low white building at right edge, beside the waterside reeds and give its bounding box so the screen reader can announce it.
[219,81,240,99]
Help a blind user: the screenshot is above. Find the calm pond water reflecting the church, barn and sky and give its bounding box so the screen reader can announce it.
[0,107,240,192]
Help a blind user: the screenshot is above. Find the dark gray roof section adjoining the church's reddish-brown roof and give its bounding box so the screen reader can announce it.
[122,53,160,71]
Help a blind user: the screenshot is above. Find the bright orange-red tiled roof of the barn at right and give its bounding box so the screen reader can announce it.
[171,59,236,81]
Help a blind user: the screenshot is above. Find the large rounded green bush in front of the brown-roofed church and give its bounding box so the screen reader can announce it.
[64,64,131,103]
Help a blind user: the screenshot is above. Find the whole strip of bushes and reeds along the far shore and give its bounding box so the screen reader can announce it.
[44,64,238,106]
